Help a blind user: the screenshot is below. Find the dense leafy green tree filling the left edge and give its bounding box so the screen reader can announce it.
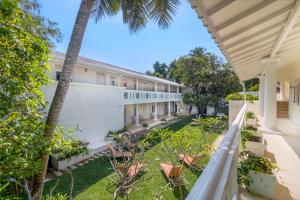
[0,0,60,196]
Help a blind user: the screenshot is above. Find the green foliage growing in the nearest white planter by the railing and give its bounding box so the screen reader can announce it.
[238,151,278,190]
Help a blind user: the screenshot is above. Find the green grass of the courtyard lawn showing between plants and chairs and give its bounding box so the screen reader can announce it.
[45,118,223,200]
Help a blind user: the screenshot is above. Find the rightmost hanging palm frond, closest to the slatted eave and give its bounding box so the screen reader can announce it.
[148,0,180,28]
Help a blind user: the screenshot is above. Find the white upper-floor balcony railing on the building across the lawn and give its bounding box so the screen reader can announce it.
[124,90,182,104]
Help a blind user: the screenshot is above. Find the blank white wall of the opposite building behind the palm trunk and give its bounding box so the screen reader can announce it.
[42,82,125,147]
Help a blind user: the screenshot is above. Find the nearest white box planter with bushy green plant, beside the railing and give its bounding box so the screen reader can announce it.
[238,151,278,199]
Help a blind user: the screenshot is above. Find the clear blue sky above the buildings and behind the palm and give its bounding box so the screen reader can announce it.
[39,0,222,72]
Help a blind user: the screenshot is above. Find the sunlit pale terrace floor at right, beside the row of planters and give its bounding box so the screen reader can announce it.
[255,118,300,200]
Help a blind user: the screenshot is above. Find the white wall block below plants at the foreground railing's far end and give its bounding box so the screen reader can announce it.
[229,100,259,125]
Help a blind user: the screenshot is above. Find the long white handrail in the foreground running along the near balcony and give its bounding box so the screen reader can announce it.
[186,103,247,200]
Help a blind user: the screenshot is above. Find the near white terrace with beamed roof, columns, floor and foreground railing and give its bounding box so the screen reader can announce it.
[187,0,300,200]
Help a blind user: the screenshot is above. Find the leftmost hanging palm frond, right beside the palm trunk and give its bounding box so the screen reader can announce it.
[91,0,120,22]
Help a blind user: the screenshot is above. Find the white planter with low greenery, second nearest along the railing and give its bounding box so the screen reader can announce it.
[241,130,266,156]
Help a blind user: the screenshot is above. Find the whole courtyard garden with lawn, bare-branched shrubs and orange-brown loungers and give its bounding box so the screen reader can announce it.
[45,117,227,199]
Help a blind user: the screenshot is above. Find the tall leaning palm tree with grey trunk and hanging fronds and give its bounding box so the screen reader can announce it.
[33,0,180,200]
